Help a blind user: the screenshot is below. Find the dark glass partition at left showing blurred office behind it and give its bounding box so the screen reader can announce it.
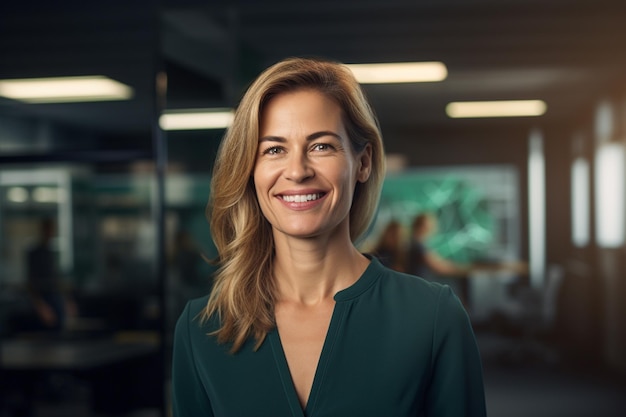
[0,161,163,415]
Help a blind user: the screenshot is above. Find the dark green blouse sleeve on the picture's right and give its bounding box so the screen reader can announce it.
[426,286,487,417]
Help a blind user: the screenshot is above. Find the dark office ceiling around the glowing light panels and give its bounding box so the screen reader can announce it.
[0,0,626,148]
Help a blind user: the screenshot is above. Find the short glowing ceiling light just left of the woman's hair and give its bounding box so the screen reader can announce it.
[159,109,235,130]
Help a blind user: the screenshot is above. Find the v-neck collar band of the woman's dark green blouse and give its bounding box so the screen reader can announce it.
[268,257,381,417]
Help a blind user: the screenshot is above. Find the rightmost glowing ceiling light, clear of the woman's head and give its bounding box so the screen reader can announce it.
[446,100,547,118]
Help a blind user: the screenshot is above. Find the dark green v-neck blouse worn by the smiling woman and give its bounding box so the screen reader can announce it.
[172,259,486,417]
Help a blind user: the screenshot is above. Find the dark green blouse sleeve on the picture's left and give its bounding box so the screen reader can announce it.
[172,304,213,417]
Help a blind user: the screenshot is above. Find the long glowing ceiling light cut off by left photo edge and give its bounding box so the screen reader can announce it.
[0,75,133,103]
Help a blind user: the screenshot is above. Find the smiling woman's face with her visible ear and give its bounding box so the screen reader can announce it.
[254,90,371,242]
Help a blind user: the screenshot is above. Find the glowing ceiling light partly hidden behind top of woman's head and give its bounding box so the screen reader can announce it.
[347,62,448,84]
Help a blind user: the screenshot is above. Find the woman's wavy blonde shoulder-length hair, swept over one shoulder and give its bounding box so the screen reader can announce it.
[202,58,385,352]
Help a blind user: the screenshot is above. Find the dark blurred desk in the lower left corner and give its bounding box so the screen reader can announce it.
[0,338,163,413]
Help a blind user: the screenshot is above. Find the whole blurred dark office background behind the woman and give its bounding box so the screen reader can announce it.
[0,0,626,417]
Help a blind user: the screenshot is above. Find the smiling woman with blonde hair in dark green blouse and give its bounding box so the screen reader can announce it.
[172,59,485,417]
